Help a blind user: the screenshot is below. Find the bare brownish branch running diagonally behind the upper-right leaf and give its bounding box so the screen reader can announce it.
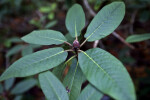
[83,0,135,49]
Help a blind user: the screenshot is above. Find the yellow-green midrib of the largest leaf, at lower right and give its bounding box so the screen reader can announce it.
[81,51,127,99]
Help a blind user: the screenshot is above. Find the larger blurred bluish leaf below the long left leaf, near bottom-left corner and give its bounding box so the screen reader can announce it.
[11,78,37,94]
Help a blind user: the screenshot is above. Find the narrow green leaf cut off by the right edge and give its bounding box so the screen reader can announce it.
[126,33,150,43]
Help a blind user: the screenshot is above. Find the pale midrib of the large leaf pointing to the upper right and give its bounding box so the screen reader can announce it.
[86,5,120,40]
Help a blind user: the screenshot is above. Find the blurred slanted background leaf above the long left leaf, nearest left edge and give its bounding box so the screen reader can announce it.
[6,45,25,57]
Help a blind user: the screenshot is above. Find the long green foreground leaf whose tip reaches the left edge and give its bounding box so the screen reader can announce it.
[0,47,67,81]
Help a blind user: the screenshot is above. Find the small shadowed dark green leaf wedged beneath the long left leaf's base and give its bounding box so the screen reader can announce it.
[52,62,66,81]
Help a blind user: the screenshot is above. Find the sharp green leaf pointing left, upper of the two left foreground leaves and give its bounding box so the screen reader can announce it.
[21,30,67,45]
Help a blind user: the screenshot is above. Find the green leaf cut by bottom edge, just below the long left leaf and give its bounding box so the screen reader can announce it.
[39,71,69,100]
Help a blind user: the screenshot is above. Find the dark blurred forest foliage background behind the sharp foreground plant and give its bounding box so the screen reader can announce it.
[0,0,150,100]
